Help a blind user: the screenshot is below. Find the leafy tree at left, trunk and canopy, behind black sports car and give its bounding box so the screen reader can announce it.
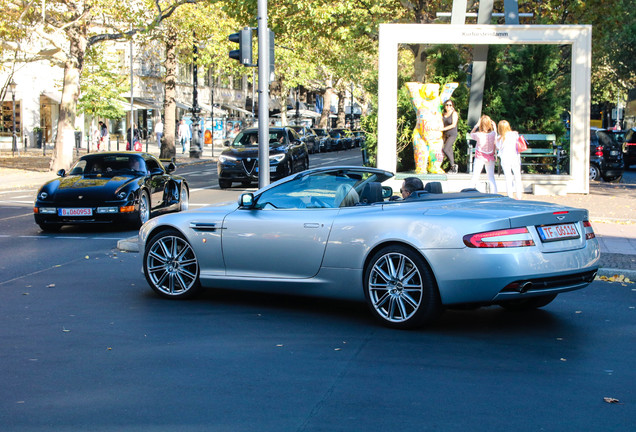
[5,0,200,170]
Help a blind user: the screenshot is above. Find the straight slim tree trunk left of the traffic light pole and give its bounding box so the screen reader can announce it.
[159,25,177,159]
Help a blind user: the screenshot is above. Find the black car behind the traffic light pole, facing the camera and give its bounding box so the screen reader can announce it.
[217,126,309,189]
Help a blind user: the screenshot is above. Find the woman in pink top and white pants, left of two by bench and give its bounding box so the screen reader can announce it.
[470,115,497,193]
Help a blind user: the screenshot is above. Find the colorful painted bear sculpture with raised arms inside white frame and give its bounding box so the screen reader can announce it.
[406,82,457,174]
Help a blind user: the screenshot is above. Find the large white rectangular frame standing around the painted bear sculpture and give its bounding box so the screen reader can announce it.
[377,24,592,193]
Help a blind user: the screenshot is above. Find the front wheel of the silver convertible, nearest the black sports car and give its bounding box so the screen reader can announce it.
[143,229,201,299]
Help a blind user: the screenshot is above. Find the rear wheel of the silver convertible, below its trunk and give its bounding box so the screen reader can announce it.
[364,245,442,329]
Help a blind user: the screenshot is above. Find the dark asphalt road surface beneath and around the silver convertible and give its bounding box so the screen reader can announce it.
[0,148,636,432]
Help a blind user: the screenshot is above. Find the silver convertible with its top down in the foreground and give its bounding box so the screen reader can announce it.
[139,167,600,328]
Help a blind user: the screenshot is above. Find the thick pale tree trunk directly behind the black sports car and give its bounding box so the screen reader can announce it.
[50,26,87,171]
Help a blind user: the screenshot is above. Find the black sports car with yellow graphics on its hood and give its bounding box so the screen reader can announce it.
[33,152,189,231]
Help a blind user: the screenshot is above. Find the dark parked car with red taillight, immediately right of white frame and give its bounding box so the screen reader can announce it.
[590,128,624,181]
